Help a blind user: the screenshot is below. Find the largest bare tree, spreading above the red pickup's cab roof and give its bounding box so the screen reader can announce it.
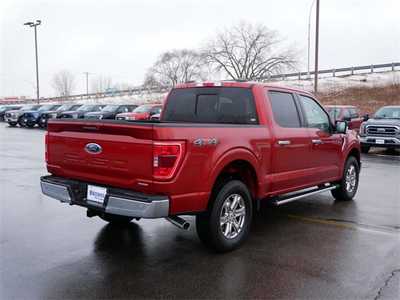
[204,22,296,80]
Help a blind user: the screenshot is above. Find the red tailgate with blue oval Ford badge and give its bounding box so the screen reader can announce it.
[46,120,153,190]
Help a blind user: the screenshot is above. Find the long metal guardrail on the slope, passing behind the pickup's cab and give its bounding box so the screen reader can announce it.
[0,62,400,104]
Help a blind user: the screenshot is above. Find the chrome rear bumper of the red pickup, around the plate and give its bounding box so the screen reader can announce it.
[40,176,169,219]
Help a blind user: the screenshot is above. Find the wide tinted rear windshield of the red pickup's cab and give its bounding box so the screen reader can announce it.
[162,87,258,124]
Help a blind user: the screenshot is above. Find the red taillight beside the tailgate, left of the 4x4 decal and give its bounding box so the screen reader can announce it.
[153,142,185,179]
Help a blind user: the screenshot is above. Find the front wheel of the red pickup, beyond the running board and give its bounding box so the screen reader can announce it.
[331,156,360,201]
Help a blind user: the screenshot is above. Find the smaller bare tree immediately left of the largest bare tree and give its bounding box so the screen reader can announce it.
[144,49,205,88]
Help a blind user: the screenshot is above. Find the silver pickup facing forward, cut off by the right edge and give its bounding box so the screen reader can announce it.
[360,105,400,153]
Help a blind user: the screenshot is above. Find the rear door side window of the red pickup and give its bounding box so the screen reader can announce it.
[268,91,300,128]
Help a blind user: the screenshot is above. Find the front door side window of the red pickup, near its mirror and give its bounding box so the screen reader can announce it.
[299,95,330,131]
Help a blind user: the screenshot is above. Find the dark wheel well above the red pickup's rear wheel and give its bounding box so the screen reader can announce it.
[209,160,258,204]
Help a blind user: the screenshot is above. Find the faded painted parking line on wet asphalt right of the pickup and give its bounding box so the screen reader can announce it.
[285,214,400,235]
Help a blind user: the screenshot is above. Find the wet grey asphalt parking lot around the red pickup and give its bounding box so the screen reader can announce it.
[0,123,400,299]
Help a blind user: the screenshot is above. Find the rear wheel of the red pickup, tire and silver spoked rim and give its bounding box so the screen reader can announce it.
[196,180,253,252]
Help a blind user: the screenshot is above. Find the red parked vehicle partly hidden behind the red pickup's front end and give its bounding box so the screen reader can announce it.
[325,105,368,132]
